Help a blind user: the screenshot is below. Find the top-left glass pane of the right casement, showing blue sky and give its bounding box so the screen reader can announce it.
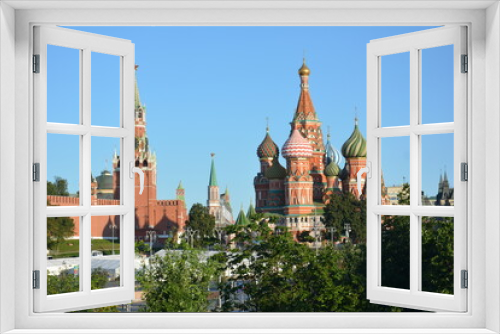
[380,52,410,127]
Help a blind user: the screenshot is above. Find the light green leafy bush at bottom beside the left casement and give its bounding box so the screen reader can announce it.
[138,250,220,312]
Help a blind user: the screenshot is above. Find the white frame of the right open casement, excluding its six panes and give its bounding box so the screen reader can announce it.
[367,25,471,312]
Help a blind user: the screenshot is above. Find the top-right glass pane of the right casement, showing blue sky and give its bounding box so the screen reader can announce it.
[421,45,454,123]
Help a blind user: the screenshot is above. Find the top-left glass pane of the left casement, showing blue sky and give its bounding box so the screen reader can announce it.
[47,45,80,124]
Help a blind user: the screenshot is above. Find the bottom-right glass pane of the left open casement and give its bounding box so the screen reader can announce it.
[91,216,121,290]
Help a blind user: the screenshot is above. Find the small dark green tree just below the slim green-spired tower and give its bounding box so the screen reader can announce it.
[186,203,215,247]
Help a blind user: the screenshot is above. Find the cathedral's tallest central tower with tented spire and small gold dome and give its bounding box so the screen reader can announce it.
[291,59,326,202]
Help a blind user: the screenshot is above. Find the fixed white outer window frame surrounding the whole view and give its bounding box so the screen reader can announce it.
[0,1,500,333]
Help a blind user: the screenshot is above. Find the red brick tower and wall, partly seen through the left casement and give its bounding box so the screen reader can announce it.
[47,66,188,242]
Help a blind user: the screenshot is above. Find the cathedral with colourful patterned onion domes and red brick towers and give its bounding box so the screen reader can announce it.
[254,60,372,231]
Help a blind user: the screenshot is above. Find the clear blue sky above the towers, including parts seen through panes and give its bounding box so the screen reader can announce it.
[48,27,453,209]
